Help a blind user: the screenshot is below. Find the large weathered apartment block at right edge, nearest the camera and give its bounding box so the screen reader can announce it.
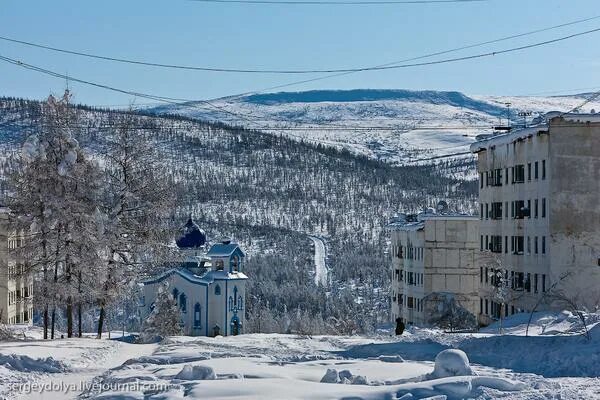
[471,113,600,323]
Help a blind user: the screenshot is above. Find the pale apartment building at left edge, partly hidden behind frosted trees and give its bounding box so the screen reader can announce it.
[0,206,33,324]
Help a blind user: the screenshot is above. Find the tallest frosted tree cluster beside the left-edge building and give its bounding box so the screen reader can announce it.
[8,91,100,338]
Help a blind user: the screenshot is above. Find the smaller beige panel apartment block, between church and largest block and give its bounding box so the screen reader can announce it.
[389,211,479,326]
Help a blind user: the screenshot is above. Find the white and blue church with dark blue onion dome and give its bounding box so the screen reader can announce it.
[141,217,248,336]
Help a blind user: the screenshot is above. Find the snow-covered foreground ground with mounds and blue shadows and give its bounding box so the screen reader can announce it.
[0,313,600,400]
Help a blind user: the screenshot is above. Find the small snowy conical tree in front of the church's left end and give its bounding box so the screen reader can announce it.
[140,282,183,343]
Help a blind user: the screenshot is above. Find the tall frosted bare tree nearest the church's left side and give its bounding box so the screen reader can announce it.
[96,113,173,337]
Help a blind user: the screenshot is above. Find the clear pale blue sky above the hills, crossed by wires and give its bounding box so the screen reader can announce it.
[0,0,600,105]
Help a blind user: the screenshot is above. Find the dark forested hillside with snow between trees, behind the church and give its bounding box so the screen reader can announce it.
[0,98,477,333]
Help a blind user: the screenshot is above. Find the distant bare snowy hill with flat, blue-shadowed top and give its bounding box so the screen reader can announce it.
[150,89,600,163]
